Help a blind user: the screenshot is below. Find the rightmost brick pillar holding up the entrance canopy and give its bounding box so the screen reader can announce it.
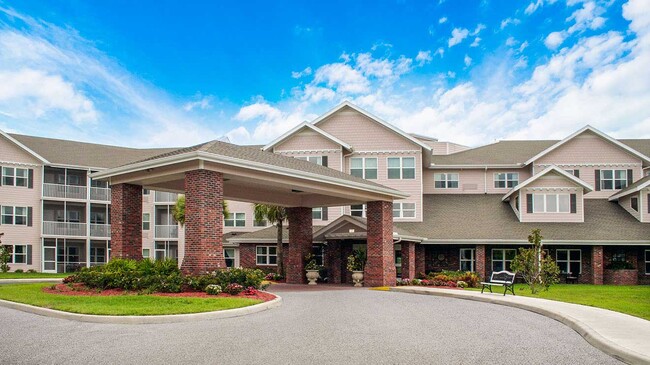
[363,201,396,286]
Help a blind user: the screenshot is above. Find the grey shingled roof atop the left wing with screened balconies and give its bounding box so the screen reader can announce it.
[9,134,178,168]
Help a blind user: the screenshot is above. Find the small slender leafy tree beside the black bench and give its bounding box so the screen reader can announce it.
[510,229,560,294]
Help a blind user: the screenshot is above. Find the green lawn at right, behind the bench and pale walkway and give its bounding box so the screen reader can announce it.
[468,284,650,320]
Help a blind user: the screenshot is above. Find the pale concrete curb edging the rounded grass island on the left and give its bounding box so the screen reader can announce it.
[0,294,282,324]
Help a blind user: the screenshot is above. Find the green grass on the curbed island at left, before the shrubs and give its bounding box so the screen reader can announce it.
[0,283,261,316]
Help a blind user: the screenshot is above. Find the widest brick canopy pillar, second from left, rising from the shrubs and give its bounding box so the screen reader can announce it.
[181,170,226,275]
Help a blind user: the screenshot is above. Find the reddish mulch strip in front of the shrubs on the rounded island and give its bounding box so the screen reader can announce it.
[43,283,276,302]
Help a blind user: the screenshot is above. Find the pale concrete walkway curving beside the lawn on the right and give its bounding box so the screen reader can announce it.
[391,286,650,364]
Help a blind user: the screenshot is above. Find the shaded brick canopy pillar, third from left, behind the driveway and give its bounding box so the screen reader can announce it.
[285,207,313,284]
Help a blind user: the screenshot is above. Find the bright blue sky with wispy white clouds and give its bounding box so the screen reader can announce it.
[0,0,650,146]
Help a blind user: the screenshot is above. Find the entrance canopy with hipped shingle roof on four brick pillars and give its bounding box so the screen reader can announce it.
[91,141,408,285]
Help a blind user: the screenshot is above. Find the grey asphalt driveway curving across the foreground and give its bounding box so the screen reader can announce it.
[0,287,619,365]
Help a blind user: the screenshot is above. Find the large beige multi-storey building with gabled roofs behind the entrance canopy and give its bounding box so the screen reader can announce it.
[0,102,650,284]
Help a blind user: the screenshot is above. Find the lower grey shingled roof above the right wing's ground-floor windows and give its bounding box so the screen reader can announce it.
[395,194,650,241]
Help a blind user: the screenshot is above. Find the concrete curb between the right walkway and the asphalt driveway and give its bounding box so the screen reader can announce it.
[390,287,650,365]
